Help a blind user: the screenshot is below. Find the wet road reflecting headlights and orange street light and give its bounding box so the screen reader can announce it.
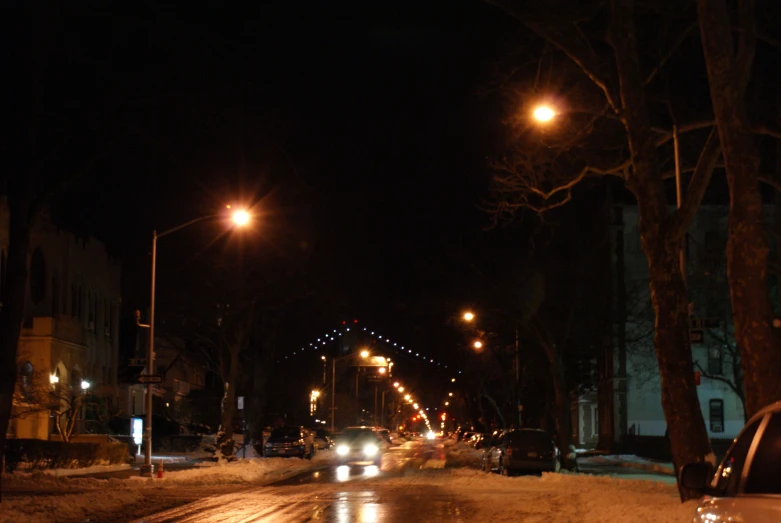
[131,443,469,523]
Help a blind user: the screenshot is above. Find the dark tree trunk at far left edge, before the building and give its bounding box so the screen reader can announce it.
[0,193,32,502]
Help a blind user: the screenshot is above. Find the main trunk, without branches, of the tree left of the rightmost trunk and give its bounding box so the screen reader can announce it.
[610,0,715,500]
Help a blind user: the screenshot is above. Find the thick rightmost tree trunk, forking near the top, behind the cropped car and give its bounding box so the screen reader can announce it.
[697,0,781,417]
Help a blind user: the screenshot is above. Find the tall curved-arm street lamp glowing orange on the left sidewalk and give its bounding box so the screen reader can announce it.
[136,205,250,478]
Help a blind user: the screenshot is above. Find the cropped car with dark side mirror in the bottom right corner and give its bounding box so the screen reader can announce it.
[680,401,781,523]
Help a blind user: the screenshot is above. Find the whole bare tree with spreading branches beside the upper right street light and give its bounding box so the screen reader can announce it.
[489,0,720,499]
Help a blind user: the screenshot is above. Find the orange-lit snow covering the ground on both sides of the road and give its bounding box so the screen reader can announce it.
[0,444,696,523]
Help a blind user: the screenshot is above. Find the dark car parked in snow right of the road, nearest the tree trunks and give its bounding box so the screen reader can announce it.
[483,429,561,476]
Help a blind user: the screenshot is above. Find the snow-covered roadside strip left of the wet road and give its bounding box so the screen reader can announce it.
[0,452,330,523]
